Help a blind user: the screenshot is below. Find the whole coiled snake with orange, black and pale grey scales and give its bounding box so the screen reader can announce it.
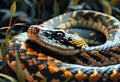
[6,10,120,82]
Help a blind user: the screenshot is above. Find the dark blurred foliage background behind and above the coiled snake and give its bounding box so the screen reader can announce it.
[0,0,120,82]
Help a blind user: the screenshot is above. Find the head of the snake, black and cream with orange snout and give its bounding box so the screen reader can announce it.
[28,24,87,55]
